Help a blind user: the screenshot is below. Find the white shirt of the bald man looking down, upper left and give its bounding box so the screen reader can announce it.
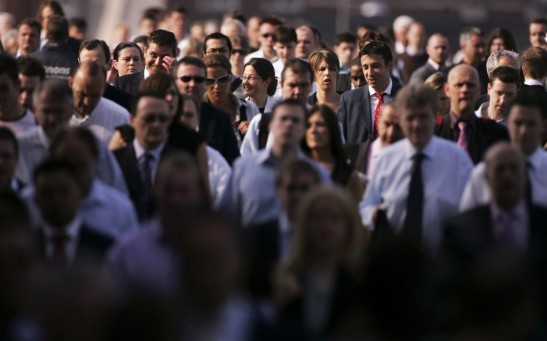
[70,97,129,143]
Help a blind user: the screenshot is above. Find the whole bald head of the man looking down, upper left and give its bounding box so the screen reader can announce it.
[69,61,106,117]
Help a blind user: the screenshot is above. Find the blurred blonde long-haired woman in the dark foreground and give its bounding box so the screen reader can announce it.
[274,187,368,339]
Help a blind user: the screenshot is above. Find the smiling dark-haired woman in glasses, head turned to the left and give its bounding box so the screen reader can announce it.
[241,58,277,114]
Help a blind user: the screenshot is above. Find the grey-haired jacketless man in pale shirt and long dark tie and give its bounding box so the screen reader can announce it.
[359,84,472,253]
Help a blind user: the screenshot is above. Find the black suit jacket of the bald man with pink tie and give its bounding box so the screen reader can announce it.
[435,113,509,164]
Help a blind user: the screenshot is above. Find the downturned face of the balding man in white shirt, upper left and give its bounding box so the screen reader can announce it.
[72,72,105,116]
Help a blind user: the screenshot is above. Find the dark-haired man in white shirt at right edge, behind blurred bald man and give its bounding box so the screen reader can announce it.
[460,94,547,211]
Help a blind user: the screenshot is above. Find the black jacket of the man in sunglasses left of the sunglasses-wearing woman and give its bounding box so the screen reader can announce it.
[199,102,239,164]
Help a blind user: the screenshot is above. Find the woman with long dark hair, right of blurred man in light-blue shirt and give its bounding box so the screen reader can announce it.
[303,105,363,202]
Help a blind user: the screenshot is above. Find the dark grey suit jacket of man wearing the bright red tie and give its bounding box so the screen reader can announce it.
[338,82,401,144]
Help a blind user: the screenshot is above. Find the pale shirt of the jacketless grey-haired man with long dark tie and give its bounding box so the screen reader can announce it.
[359,136,473,253]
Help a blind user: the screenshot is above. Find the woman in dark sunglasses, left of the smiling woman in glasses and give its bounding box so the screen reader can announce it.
[203,54,258,142]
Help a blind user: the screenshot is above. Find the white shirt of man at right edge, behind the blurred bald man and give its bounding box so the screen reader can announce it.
[460,147,547,212]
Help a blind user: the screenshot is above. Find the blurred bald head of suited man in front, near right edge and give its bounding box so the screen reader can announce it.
[484,142,526,210]
